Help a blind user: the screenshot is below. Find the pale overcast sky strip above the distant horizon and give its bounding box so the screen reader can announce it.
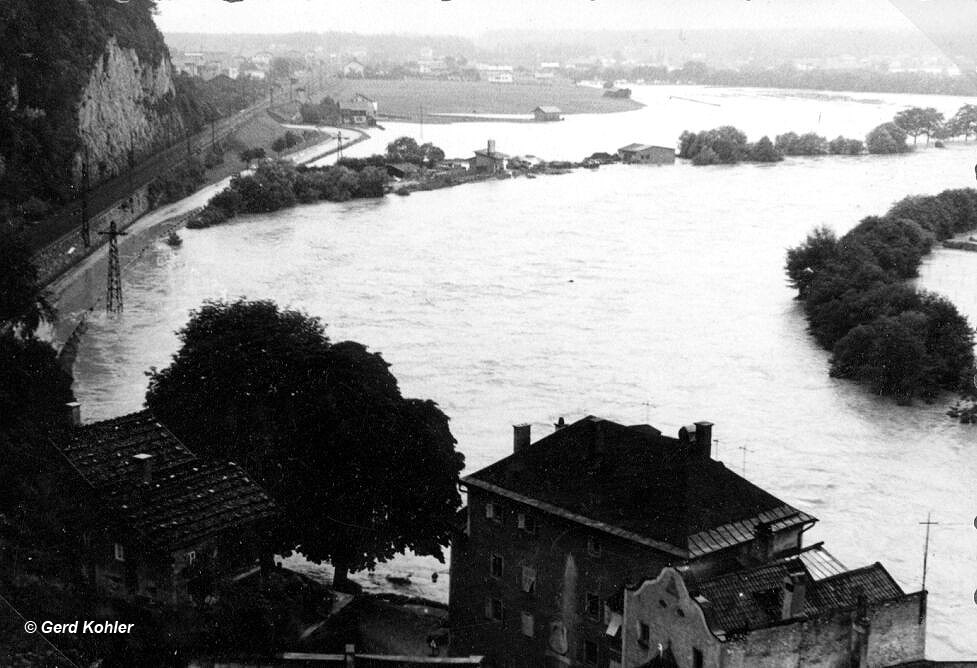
[156,0,916,37]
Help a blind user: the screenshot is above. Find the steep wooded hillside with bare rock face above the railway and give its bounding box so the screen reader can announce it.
[0,0,186,217]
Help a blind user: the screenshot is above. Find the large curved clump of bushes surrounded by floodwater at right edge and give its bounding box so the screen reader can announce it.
[786,189,977,401]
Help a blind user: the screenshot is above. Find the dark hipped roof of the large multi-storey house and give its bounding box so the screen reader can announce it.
[464,416,816,558]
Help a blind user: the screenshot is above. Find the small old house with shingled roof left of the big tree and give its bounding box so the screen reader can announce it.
[53,406,277,604]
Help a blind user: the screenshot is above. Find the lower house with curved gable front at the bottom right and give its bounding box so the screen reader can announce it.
[622,557,926,668]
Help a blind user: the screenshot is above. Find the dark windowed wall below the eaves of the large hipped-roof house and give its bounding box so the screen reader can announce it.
[450,488,667,668]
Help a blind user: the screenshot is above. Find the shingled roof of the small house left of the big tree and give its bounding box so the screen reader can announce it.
[55,411,276,551]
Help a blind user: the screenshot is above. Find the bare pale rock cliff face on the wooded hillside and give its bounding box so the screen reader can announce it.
[72,37,184,183]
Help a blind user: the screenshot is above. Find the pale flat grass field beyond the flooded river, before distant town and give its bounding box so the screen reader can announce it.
[304,79,642,122]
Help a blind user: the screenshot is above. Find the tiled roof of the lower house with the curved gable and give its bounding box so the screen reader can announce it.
[686,559,905,635]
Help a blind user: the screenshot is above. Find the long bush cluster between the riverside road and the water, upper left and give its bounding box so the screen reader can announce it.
[187,160,387,228]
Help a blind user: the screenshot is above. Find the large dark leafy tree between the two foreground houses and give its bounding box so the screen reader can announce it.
[146,300,464,586]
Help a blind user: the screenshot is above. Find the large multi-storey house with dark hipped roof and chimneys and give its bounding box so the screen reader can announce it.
[450,417,816,667]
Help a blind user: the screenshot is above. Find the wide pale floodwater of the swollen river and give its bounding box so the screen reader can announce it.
[60,87,977,658]
